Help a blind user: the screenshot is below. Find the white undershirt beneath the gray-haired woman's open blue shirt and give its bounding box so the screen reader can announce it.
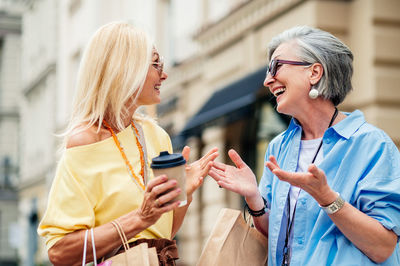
[289,138,324,220]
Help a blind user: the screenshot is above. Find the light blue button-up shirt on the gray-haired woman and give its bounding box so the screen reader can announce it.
[259,110,400,266]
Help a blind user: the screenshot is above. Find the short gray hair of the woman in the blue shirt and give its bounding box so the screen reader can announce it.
[268,26,353,106]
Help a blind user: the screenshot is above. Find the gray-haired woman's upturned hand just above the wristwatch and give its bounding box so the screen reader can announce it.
[265,156,337,206]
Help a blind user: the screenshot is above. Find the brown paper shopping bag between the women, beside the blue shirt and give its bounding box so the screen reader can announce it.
[197,208,268,266]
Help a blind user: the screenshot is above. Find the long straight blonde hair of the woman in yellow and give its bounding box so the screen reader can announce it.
[62,22,153,142]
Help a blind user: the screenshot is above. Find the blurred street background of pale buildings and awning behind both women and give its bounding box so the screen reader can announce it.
[0,0,400,266]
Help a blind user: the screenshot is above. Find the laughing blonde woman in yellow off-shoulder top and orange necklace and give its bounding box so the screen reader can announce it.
[38,22,218,265]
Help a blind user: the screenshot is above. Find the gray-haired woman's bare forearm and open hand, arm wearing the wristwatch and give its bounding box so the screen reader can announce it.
[265,156,397,263]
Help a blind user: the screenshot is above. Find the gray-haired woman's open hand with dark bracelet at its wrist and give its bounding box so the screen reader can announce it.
[209,150,259,198]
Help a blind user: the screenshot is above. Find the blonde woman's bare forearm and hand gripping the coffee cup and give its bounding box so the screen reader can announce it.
[48,175,181,265]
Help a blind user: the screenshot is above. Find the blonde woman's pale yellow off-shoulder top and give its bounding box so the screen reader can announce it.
[38,120,173,249]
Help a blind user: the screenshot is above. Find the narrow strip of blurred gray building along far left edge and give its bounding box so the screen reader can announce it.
[0,0,21,266]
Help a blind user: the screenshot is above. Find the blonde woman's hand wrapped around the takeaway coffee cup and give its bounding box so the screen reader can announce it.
[137,175,182,228]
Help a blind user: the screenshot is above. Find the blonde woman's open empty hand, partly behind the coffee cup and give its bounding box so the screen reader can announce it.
[182,146,218,197]
